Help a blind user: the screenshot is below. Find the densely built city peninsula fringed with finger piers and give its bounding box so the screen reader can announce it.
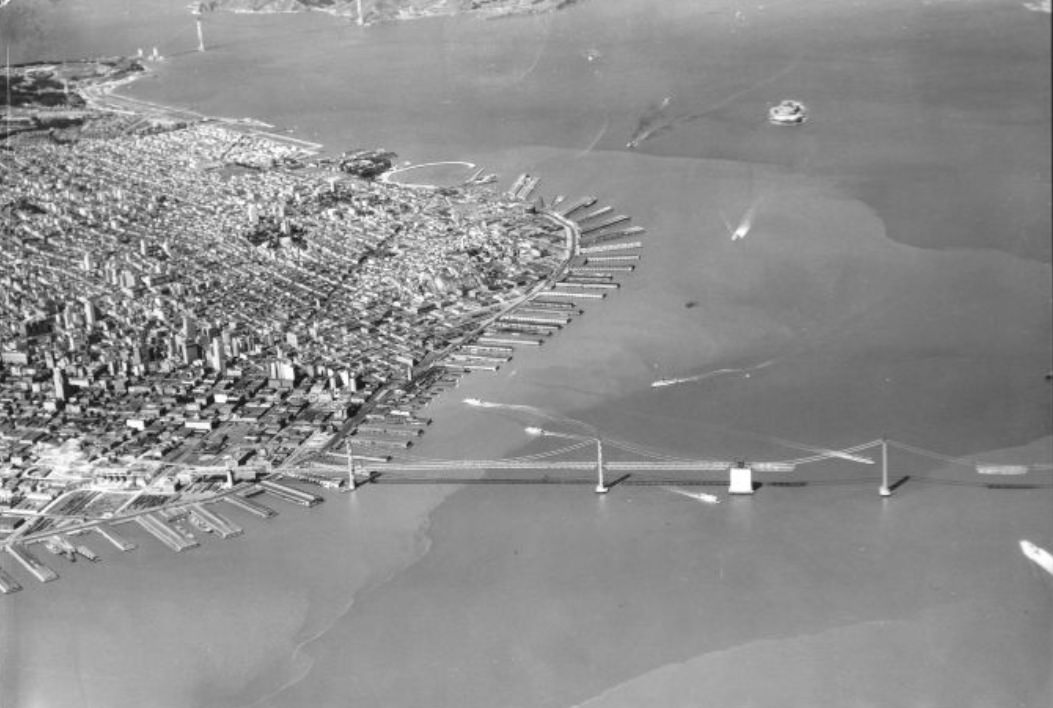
[0,59,642,592]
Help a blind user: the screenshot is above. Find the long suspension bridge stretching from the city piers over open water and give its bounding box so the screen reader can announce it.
[299,429,1053,497]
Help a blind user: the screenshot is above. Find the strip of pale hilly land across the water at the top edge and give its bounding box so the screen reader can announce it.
[208,0,578,23]
